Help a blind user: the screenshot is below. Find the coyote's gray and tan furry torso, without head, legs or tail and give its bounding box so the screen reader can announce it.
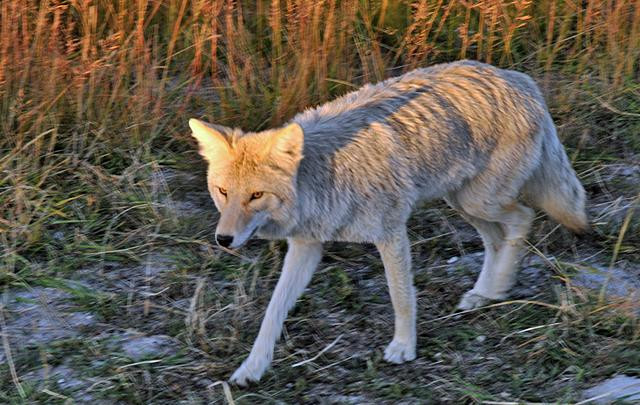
[259,61,557,242]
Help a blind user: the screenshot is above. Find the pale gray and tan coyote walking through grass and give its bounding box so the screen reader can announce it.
[189,61,588,385]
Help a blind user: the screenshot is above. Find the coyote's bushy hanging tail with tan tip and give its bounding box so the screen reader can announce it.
[523,117,589,233]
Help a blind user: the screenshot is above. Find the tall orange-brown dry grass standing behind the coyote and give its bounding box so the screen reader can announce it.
[0,0,640,284]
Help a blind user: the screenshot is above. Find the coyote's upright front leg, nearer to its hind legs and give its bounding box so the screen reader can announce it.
[376,228,416,363]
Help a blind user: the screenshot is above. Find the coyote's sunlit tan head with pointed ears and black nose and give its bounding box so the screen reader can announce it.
[189,119,304,248]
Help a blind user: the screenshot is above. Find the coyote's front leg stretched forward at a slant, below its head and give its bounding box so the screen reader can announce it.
[231,239,322,385]
